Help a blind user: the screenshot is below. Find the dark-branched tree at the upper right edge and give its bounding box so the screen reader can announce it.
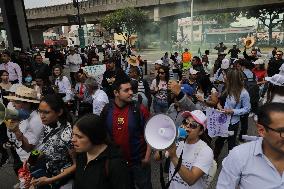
[244,6,284,45]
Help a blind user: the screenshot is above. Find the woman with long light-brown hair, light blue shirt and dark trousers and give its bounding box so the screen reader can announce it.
[214,69,251,159]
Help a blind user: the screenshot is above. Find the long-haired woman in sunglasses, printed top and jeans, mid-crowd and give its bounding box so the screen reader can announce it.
[150,66,169,113]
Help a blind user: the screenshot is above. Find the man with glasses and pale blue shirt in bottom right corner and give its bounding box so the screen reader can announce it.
[219,103,284,189]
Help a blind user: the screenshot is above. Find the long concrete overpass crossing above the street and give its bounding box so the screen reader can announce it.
[0,0,284,45]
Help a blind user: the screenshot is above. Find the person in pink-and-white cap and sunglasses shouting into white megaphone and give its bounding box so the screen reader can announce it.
[154,110,216,189]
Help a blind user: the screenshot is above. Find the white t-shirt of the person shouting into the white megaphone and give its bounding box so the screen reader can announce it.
[169,140,213,189]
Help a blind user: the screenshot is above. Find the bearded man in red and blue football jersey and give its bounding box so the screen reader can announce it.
[101,75,152,189]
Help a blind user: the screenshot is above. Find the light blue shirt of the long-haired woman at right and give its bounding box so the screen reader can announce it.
[224,89,251,125]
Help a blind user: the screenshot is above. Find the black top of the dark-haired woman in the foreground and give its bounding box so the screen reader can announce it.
[74,146,130,189]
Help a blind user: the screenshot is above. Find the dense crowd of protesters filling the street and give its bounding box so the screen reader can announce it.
[0,43,284,189]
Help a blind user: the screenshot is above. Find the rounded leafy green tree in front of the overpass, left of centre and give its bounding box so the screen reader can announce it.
[102,7,148,44]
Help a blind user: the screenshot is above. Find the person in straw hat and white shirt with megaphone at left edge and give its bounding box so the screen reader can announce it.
[0,86,43,174]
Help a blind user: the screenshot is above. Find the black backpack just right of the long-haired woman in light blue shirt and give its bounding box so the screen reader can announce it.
[243,73,260,107]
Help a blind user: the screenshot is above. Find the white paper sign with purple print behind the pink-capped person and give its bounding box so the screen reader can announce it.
[206,108,231,137]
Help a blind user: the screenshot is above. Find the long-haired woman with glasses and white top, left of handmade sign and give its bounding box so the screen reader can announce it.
[52,65,73,103]
